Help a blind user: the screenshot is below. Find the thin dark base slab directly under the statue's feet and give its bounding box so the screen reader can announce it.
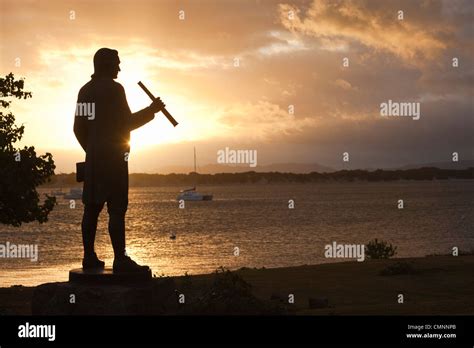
[69,267,152,285]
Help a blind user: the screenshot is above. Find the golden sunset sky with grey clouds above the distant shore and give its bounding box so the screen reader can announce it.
[0,0,474,173]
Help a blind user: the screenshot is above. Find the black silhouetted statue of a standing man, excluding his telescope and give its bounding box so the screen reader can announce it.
[74,48,165,272]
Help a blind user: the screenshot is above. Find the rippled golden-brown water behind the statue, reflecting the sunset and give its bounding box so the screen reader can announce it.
[0,181,474,287]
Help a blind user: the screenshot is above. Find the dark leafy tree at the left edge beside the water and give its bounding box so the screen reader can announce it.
[0,73,56,227]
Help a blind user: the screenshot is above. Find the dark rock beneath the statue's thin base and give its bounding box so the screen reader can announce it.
[32,278,177,315]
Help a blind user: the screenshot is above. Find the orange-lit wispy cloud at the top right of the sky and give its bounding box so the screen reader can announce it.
[279,0,460,65]
